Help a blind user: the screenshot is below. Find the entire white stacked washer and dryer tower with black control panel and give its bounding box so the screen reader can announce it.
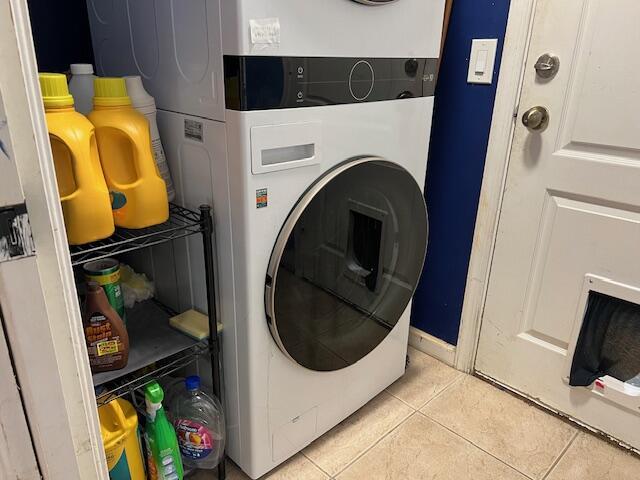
[88,0,444,478]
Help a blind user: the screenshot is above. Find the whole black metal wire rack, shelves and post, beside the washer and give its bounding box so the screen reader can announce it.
[69,204,226,479]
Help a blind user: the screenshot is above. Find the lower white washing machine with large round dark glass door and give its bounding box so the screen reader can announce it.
[156,98,432,478]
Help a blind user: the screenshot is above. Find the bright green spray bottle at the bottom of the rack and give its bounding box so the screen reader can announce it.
[144,382,184,480]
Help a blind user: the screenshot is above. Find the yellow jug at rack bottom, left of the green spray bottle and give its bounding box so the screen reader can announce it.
[98,398,146,480]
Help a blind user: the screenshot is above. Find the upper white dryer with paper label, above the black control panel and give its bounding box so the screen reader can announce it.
[87,0,444,120]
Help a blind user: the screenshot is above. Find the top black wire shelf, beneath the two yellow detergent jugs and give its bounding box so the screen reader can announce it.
[69,203,205,267]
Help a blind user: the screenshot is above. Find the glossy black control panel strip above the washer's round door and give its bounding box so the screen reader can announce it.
[224,55,438,110]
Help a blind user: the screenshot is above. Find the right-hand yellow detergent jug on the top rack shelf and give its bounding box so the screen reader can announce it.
[89,77,169,228]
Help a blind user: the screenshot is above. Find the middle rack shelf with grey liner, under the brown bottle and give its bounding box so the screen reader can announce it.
[93,300,209,405]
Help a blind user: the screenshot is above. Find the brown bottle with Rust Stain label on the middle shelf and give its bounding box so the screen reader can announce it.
[82,282,129,373]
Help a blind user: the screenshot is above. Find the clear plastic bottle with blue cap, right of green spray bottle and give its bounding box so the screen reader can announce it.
[171,375,226,469]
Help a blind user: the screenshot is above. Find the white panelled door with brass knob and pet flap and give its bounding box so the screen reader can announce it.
[476,0,640,448]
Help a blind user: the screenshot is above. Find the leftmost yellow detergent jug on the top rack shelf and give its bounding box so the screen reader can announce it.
[40,73,114,245]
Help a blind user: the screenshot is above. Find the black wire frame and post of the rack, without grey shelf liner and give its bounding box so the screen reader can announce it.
[69,203,226,480]
